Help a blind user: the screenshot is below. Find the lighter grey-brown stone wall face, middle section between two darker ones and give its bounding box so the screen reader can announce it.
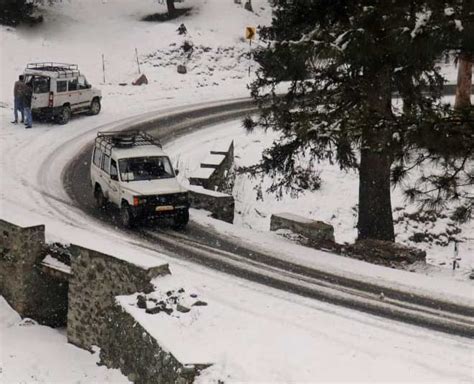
[67,246,170,350]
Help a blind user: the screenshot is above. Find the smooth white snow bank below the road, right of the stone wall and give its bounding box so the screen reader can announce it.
[118,270,473,383]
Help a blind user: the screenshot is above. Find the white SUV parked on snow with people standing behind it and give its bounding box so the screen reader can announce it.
[23,63,102,124]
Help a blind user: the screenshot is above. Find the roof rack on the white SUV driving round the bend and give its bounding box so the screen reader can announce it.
[95,130,162,155]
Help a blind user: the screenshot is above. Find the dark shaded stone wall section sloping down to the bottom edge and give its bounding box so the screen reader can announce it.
[100,304,204,384]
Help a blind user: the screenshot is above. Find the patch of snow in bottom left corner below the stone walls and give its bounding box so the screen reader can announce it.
[0,296,129,384]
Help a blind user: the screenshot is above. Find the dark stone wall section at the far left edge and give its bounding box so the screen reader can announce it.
[0,220,68,326]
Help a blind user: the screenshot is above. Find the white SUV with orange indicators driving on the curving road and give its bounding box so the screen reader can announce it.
[90,131,189,228]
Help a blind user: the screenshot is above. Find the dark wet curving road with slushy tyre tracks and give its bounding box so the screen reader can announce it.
[63,99,474,338]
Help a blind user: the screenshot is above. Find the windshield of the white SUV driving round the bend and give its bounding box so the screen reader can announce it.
[119,156,174,181]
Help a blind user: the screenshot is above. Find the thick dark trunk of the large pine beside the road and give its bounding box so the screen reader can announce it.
[357,70,395,241]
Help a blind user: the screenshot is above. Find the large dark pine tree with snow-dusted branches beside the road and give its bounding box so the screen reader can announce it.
[250,0,474,241]
